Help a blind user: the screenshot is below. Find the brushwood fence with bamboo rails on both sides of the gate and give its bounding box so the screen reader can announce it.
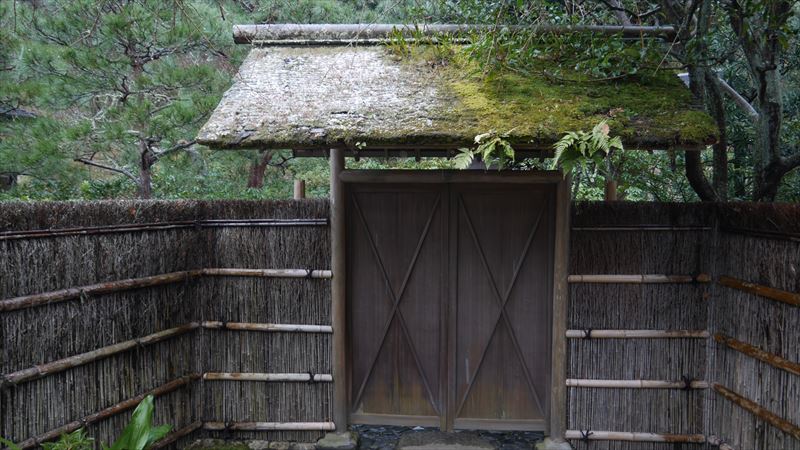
[0,201,800,450]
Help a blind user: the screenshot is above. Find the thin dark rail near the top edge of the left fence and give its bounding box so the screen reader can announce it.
[0,219,328,241]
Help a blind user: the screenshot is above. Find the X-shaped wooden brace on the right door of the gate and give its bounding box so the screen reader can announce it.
[455,197,547,417]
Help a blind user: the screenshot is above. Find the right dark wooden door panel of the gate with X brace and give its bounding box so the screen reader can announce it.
[450,185,552,428]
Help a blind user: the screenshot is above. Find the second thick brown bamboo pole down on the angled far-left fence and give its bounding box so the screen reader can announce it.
[2,322,200,387]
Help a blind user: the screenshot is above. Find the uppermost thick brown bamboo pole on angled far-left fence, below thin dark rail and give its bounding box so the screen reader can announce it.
[0,270,200,312]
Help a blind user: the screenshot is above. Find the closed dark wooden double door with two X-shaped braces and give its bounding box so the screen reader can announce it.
[346,173,555,430]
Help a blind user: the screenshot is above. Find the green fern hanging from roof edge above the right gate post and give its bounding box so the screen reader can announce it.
[552,120,624,179]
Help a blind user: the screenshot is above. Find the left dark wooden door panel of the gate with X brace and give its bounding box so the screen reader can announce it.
[347,185,445,416]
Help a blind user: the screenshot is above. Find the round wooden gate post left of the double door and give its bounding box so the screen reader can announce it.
[329,148,348,432]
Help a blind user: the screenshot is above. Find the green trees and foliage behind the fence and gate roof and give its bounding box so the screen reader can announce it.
[0,0,800,201]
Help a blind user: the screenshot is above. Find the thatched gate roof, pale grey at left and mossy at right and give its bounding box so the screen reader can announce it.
[198,24,716,154]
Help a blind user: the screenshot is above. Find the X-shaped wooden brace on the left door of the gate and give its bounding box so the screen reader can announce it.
[353,195,441,414]
